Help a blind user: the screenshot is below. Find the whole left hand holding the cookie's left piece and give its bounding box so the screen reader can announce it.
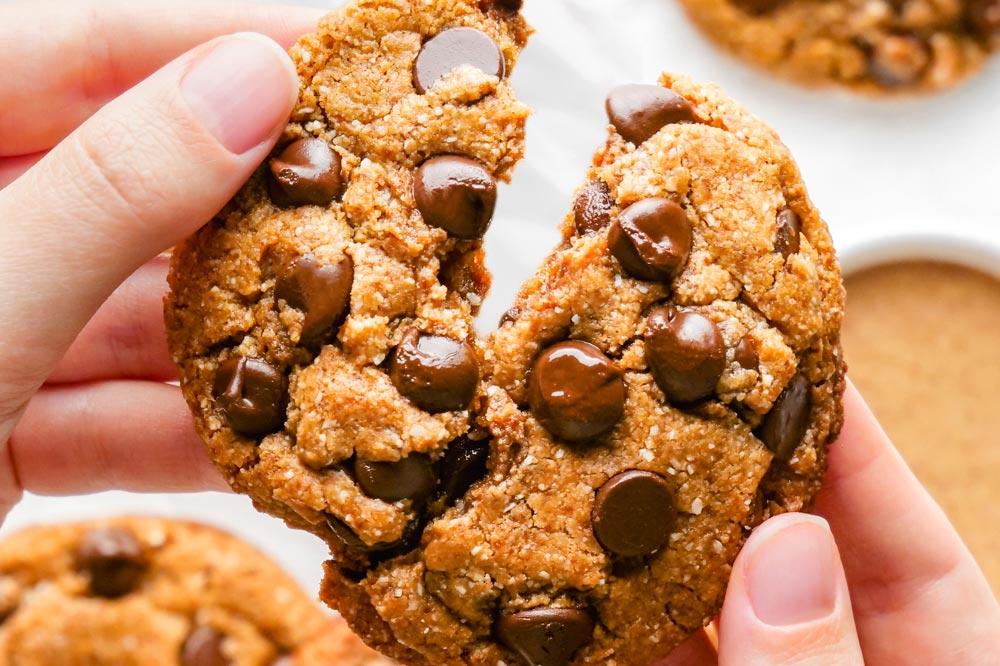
[0,0,318,519]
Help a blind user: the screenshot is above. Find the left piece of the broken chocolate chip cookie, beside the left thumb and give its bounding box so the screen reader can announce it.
[166,0,529,568]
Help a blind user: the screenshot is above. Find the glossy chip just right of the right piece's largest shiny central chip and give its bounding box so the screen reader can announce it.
[645,307,726,403]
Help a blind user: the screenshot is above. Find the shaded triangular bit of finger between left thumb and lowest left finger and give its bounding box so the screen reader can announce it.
[46,257,177,385]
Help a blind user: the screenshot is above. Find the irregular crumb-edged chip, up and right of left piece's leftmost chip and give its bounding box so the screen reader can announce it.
[274,254,354,344]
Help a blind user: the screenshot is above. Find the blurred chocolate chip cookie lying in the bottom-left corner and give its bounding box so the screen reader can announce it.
[0,517,391,666]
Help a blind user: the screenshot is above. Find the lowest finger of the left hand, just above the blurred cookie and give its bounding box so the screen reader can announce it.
[8,381,226,495]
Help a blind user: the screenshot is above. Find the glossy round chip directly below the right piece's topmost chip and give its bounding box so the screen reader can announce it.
[608,198,692,280]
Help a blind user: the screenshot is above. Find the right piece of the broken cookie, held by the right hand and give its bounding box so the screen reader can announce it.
[322,76,844,666]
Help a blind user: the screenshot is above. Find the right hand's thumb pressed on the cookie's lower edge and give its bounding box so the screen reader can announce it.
[719,514,860,666]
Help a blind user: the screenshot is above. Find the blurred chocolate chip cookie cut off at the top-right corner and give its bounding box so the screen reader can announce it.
[681,0,1000,92]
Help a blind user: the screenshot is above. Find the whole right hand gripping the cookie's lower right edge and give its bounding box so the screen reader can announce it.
[661,378,1000,666]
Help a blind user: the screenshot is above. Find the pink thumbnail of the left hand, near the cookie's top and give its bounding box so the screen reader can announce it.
[181,34,295,155]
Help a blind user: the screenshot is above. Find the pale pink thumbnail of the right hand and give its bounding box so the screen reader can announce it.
[747,521,841,627]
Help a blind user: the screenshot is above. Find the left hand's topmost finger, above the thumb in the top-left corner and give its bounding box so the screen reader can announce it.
[0,0,322,154]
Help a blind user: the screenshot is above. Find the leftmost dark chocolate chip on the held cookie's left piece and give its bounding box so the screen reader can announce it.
[214,356,288,437]
